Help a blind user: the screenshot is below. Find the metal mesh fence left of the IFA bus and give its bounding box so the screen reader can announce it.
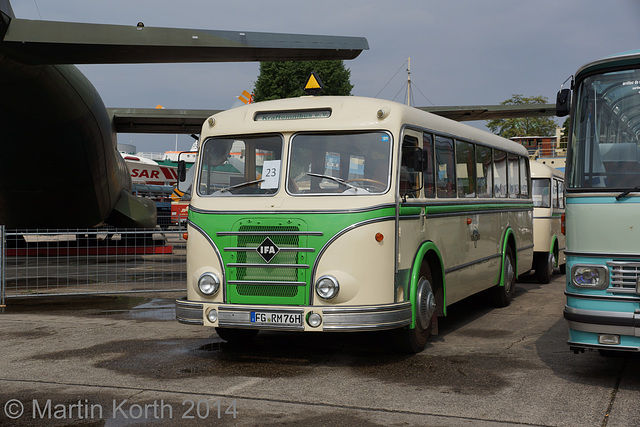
[0,226,186,308]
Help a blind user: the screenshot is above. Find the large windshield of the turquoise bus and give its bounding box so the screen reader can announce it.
[567,69,640,191]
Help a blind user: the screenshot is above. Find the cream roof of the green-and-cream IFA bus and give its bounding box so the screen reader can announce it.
[202,96,527,156]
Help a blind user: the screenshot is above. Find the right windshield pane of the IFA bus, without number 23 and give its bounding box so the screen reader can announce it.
[287,132,391,195]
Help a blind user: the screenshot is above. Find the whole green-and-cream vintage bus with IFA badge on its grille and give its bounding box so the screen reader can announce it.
[176,96,533,352]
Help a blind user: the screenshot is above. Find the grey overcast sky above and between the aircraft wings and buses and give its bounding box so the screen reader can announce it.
[11,0,640,151]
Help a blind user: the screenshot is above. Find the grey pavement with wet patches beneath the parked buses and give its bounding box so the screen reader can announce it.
[0,275,640,426]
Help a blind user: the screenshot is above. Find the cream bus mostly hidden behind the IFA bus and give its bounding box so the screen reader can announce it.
[530,161,566,283]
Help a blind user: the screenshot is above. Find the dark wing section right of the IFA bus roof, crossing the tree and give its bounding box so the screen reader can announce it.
[417,104,556,122]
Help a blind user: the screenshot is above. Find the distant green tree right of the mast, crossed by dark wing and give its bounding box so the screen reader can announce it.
[487,94,557,138]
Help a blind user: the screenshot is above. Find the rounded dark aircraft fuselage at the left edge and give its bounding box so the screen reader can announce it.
[0,57,153,228]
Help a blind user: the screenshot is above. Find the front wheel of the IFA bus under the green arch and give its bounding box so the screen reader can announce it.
[395,267,437,354]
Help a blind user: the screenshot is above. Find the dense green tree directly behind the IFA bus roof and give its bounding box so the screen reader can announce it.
[253,60,353,101]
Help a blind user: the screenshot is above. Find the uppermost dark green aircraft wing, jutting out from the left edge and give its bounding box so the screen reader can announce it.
[0,13,369,65]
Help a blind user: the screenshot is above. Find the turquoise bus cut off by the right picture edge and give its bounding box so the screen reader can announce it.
[557,51,640,353]
